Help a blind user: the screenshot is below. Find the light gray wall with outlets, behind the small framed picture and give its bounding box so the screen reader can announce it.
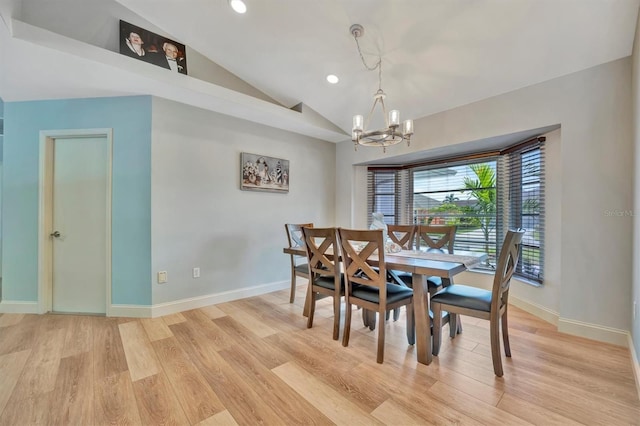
[151,98,336,305]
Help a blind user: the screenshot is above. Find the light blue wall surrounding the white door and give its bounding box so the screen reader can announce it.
[2,96,151,305]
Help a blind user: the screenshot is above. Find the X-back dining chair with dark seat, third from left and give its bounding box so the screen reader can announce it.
[338,228,415,364]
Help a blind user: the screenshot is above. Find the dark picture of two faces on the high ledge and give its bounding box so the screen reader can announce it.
[120,20,187,74]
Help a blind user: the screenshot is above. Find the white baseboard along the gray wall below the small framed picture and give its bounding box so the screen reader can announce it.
[151,280,291,318]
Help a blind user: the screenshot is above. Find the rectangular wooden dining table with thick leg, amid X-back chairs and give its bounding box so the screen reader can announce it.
[283,247,487,364]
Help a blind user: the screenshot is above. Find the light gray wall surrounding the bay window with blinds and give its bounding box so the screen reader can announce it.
[336,58,633,343]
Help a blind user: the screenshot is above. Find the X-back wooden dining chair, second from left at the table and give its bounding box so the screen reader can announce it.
[302,228,345,340]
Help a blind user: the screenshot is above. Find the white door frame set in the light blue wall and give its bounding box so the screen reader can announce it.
[38,128,113,316]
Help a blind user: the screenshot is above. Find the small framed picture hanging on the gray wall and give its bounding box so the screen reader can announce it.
[240,152,289,192]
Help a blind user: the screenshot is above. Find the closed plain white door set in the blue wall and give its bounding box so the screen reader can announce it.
[51,136,110,314]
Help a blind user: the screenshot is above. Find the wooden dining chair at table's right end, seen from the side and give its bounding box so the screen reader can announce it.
[431,229,525,377]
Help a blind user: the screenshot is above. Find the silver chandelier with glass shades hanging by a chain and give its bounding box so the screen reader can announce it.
[349,24,413,152]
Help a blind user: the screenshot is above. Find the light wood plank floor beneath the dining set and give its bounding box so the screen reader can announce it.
[0,286,640,425]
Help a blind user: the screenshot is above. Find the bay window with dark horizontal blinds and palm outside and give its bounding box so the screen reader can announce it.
[368,137,544,283]
